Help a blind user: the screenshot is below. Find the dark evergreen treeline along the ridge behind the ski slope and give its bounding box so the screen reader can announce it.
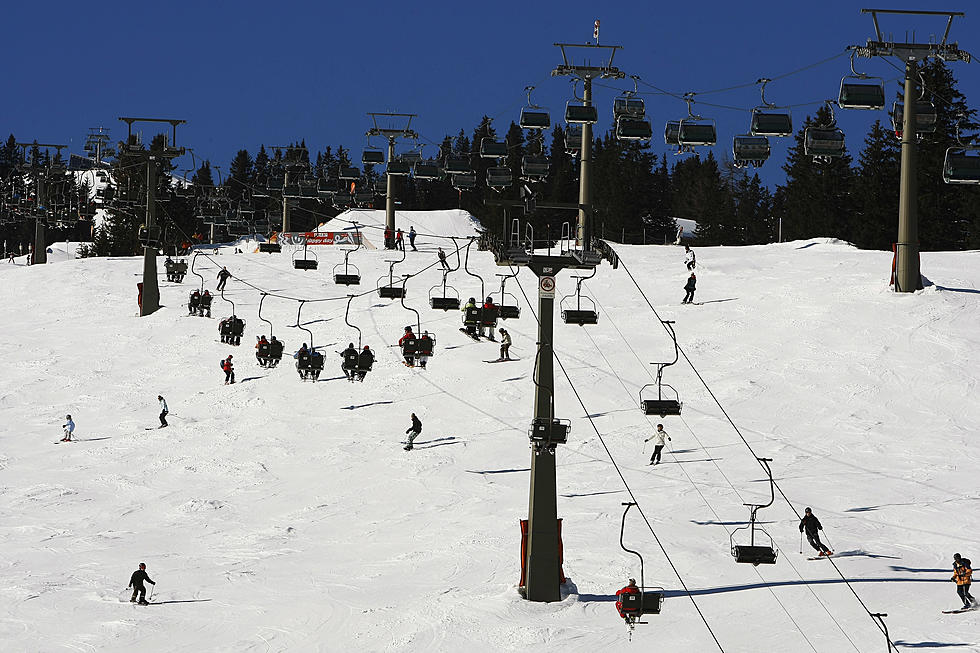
[7,61,980,255]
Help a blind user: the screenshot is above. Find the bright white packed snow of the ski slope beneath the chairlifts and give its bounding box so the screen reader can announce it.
[0,214,980,653]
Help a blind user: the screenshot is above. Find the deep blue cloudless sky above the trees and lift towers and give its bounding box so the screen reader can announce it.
[7,0,980,185]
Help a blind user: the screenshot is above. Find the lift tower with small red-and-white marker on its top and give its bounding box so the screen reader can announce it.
[551,42,626,249]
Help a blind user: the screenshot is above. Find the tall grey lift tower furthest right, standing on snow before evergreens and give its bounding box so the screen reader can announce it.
[850,9,971,292]
